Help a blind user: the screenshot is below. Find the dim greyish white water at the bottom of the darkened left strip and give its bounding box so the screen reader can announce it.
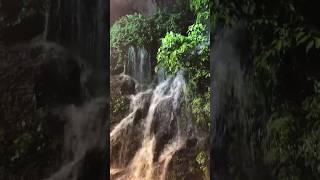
[48,98,106,180]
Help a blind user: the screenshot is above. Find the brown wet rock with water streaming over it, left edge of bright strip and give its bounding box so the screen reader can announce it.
[110,91,152,166]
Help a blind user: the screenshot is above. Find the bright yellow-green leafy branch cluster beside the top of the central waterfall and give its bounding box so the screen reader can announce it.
[156,24,210,89]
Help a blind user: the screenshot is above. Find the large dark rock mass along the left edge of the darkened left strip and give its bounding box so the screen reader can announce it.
[0,43,83,178]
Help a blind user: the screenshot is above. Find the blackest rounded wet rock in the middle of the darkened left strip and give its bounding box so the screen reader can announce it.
[32,44,85,105]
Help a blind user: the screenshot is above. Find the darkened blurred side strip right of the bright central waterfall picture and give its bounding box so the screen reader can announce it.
[211,0,320,180]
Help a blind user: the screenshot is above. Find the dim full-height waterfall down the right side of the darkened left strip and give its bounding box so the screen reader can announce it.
[46,0,108,180]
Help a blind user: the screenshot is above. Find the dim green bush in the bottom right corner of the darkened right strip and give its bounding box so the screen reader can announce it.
[263,82,320,179]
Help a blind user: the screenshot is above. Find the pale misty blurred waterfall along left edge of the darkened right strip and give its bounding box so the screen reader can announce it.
[211,23,246,179]
